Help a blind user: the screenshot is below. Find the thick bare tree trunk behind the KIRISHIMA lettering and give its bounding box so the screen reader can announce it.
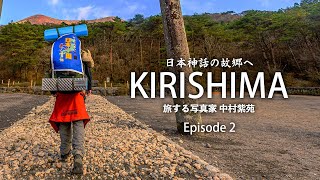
[160,0,202,133]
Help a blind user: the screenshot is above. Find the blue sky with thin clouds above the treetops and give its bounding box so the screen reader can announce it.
[0,0,300,25]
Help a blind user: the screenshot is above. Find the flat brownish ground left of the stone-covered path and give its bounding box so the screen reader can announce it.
[0,93,49,131]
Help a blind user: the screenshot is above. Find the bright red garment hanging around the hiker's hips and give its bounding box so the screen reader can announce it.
[49,92,90,132]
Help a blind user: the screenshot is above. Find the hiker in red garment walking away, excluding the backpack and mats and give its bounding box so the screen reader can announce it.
[49,50,94,174]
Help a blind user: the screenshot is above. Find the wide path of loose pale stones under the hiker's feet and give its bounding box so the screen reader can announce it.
[0,95,232,180]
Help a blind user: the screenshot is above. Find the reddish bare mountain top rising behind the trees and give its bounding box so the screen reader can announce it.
[17,14,115,25]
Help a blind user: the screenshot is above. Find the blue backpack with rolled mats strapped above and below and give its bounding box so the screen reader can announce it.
[42,24,88,91]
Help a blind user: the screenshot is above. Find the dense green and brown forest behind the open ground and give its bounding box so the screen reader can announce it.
[0,0,320,86]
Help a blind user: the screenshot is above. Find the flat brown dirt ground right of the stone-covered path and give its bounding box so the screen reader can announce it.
[107,96,320,179]
